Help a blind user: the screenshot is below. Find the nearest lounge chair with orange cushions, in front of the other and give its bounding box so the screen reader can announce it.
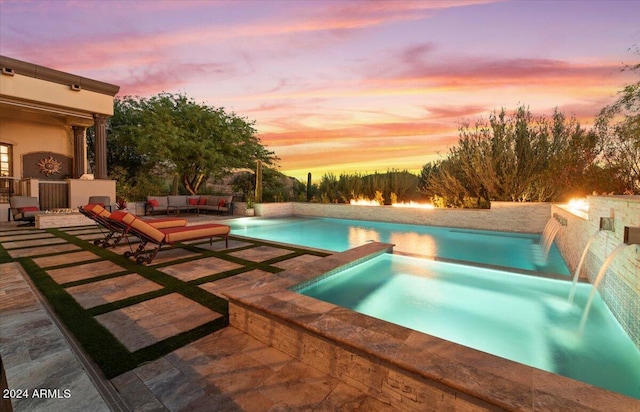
[108,212,231,264]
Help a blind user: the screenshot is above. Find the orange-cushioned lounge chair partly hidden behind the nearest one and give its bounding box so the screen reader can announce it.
[78,204,187,248]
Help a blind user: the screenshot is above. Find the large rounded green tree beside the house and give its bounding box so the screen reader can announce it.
[90,93,277,198]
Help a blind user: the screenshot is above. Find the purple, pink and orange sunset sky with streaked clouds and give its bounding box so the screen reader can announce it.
[0,0,640,181]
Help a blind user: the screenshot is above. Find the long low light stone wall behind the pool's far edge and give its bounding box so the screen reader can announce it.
[256,202,551,233]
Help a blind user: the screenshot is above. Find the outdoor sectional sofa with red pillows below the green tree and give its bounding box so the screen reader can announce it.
[144,196,233,215]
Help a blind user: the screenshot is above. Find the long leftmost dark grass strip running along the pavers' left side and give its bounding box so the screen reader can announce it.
[18,258,137,377]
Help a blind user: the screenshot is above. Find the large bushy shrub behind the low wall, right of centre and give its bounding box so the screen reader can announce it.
[420,107,597,207]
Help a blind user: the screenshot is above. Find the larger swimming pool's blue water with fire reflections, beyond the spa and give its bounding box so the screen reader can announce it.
[229,217,569,276]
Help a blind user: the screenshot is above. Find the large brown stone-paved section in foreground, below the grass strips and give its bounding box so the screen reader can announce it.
[112,327,389,412]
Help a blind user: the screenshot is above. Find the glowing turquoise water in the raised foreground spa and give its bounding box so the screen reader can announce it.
[294,254,640,399]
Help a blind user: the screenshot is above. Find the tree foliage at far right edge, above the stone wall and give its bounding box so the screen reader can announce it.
[595,47,640,194]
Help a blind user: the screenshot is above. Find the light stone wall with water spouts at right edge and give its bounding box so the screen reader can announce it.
[553,196,640,348]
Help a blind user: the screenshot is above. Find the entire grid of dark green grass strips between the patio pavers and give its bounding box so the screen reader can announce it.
[0,225,336,379]
